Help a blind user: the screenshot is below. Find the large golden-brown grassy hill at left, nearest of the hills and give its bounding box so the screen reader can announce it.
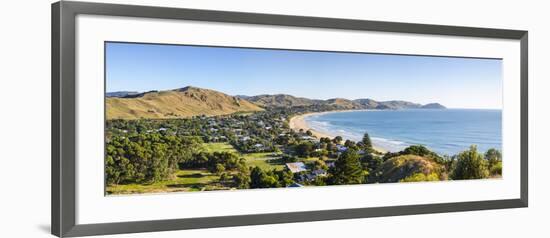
[106,87,263,119]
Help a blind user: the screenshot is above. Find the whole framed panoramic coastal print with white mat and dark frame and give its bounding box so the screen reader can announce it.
[52,1,528,237]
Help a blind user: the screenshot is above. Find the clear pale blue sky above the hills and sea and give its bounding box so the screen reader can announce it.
[106,43,502,109]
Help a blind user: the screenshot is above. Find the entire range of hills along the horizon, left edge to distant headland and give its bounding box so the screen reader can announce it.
[105,86,445,119]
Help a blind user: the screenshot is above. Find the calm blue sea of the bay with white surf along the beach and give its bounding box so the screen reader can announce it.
[305,109,502,155]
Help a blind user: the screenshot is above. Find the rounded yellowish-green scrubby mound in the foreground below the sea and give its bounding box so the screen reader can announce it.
[376,155,446,183]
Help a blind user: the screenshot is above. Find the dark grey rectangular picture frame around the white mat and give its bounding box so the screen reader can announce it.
[51,1,528,237]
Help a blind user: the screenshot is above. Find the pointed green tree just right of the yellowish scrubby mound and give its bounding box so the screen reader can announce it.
[451,145,489,180]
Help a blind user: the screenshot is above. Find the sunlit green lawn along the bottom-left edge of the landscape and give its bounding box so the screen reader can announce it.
[107,170,228,194]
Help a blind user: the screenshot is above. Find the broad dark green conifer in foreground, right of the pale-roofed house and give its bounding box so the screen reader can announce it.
[329,150,365,184]
